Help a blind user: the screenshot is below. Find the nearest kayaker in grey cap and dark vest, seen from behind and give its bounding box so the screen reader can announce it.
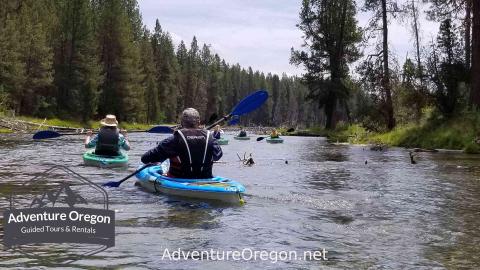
[142,108,223,178]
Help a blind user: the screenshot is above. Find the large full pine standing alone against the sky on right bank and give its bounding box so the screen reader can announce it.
[291,0,361,129]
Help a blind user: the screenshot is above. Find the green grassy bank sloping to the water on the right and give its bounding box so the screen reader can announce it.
[300,113,480,153]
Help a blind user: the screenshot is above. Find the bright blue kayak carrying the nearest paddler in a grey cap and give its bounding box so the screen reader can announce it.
[136,166,245,204]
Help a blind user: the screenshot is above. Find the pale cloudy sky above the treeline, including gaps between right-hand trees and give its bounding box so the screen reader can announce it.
[139,0,438,75]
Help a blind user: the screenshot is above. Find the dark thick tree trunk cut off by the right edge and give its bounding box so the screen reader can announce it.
[470,0,480,106]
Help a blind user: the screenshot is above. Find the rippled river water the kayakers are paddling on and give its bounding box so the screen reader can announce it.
[0,133,480,269]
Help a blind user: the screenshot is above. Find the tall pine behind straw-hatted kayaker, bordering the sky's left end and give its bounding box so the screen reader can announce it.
[98,0,146,122]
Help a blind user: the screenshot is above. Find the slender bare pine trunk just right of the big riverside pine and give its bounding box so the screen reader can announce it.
[382,0,395,130]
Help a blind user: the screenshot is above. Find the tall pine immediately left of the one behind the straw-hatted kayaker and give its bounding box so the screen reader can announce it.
[55,0,101,122]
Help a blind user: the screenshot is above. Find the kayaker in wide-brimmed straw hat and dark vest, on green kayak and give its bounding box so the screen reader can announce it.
[85,114,130,156]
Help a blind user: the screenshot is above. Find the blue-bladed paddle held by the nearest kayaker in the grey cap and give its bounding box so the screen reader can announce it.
[103,90,268,187]
